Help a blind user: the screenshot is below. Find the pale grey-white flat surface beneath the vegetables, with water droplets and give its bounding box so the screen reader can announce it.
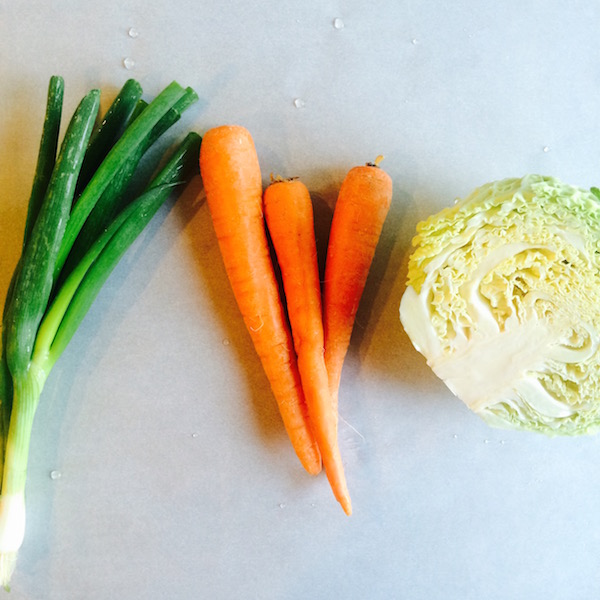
[0,0,600,600]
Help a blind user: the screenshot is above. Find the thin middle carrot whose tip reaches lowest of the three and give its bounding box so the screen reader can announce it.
[263,179,352,515]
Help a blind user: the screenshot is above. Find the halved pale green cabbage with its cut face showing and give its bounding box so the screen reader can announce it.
[400,175,600,435]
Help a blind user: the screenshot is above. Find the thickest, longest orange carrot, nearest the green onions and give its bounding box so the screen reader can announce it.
[200,125,321,474]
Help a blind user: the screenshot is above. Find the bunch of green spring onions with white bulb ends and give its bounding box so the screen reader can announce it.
[0,76,200,587]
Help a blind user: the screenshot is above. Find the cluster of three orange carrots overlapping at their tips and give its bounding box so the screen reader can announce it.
[200,125,392,515]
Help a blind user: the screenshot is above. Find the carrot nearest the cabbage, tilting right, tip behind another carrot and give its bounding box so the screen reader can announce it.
[323,157,392,412]
